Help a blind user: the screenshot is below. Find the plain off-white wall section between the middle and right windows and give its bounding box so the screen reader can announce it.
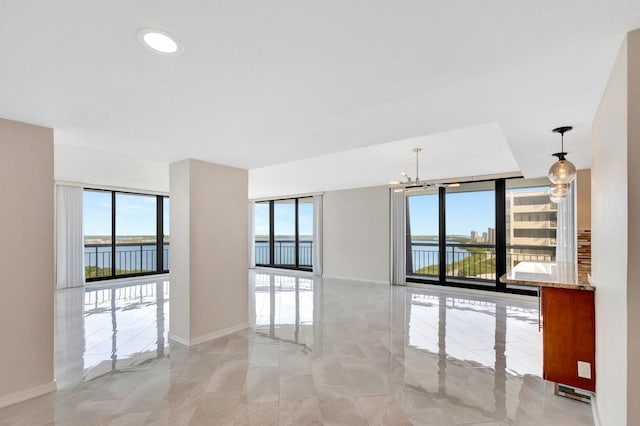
[322,186,389,283]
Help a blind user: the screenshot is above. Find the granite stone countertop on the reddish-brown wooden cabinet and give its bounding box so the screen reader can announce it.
[500,262,595,291]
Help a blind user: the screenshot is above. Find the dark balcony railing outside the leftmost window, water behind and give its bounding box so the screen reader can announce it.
[84,243,170,278]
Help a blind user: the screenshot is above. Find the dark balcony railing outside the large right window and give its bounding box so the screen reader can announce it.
[407,242,556,280]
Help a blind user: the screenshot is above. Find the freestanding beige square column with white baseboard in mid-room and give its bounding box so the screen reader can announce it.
[170,160,249,344]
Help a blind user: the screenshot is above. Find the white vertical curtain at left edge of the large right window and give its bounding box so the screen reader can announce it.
[389,190,407,285]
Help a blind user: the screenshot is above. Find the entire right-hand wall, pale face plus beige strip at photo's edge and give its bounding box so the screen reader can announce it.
[591,31,640,425]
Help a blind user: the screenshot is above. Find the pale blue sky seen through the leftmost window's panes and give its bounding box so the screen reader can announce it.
[83,191,170,236]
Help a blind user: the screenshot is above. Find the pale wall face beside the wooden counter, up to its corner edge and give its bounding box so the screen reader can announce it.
[591,34,640,425]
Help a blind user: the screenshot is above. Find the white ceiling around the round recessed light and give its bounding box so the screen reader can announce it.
[0,0,640,193]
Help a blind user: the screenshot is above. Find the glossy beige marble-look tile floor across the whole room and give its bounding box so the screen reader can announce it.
[0,271,593,425]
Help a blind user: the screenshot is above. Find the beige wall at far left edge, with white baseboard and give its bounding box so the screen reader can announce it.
[0,119,55,402]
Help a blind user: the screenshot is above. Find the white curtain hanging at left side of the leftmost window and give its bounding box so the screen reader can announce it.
[56,185,84,288]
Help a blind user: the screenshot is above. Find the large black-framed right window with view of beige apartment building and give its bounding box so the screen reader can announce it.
[406,179,557,292]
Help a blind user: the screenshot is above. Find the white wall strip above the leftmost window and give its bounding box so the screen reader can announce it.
[54,145,169,192]
